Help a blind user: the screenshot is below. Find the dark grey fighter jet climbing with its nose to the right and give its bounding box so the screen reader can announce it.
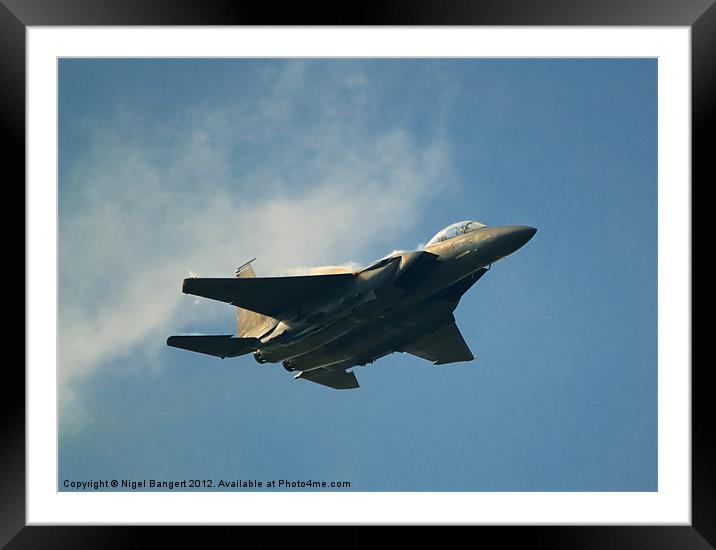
[167,221,537,389]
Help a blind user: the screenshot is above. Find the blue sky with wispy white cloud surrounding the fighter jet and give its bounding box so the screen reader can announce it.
[59,59,658,491]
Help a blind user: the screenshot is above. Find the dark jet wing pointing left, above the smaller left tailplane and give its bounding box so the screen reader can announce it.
[182,273,353,317]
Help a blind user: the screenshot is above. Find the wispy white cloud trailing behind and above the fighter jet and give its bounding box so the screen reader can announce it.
[59,62,450,432]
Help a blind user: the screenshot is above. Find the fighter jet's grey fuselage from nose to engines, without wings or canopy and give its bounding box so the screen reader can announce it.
[255,226,535,371]
